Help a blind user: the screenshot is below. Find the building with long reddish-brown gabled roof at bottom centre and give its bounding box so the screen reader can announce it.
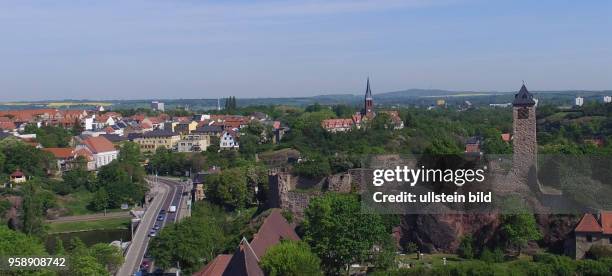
[193,209,300,276]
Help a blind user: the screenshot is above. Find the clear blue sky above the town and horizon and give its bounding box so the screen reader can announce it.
[0,0,612,101]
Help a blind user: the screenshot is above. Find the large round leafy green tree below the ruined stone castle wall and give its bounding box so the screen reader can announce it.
[303,193,389,273]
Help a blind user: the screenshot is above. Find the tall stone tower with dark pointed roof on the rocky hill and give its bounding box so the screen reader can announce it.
[512,84,538,184]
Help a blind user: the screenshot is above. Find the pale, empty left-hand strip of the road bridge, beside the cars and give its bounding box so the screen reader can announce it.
[116,178,175,276]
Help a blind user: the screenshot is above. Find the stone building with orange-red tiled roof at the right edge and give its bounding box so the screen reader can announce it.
[574,211,612,259]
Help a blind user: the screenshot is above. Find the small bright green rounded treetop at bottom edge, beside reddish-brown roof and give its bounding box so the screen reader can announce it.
[260,241,323,276]
